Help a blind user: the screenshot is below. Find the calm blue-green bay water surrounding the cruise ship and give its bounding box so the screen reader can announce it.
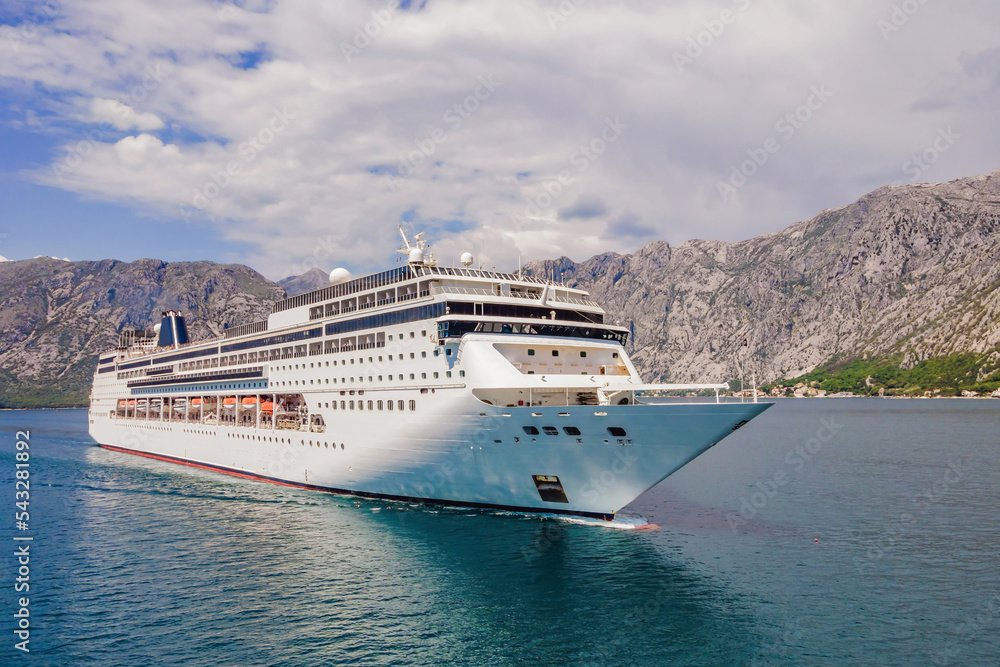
[0,399,1000,665]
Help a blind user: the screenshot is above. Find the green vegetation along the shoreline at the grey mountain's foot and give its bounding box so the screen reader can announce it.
[768,353,1000,396]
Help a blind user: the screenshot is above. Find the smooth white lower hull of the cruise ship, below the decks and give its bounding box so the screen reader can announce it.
[91,389,770,519]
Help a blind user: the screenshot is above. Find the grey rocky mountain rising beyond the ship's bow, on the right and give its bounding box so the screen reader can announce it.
[526,172,1000,382]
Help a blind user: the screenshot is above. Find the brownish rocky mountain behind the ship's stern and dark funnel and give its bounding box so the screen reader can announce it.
[0,258,285,407]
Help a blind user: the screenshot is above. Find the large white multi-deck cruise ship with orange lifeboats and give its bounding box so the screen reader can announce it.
[89,229,770,520]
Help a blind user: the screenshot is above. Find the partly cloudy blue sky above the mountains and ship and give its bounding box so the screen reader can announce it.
[0,0,1000,279]
